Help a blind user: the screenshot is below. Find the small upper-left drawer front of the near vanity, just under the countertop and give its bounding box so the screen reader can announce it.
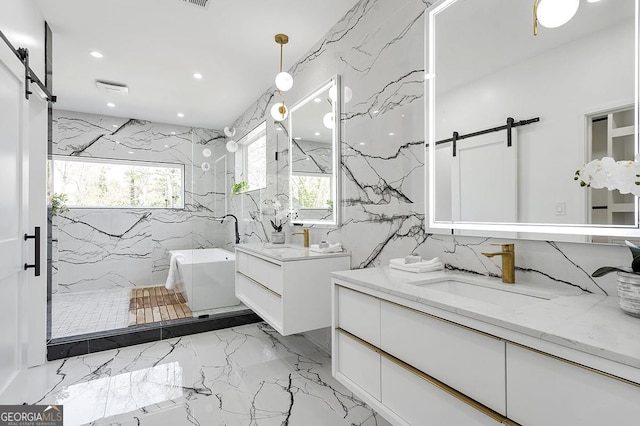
[336,286,380,347]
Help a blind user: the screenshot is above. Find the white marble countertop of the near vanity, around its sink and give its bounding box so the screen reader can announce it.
[333,267,640,368]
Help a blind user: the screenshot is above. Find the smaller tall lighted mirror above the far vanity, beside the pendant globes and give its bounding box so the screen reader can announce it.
[289,75,342,225]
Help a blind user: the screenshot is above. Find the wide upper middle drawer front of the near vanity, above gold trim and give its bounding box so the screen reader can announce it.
[380,301,506,415]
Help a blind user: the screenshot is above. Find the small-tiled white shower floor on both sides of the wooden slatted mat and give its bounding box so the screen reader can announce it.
[51,288,247,339]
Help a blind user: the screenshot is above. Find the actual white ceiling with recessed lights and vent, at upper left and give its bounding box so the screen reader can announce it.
[35,0,357,129]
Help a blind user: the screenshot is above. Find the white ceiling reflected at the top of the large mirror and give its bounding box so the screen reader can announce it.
[435,0,635,93]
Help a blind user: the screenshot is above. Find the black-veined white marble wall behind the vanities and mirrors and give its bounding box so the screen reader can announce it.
[226,0,631,302]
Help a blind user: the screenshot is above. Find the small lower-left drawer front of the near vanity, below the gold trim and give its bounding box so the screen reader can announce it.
[334,332,380,401]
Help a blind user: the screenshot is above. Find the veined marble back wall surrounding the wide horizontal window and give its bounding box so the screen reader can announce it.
[52,110,232,293]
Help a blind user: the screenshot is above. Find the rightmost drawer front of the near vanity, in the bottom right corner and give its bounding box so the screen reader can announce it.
[507,344,640,426]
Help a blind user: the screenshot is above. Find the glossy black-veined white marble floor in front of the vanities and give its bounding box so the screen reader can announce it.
[0,323,389,426]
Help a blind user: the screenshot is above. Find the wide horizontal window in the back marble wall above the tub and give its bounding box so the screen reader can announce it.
[51,157,184,209]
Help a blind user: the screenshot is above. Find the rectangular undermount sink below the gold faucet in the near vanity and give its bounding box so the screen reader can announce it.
[415,280,551,308]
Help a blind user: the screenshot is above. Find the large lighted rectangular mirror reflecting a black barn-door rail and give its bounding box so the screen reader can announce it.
[426,0,640,242]
